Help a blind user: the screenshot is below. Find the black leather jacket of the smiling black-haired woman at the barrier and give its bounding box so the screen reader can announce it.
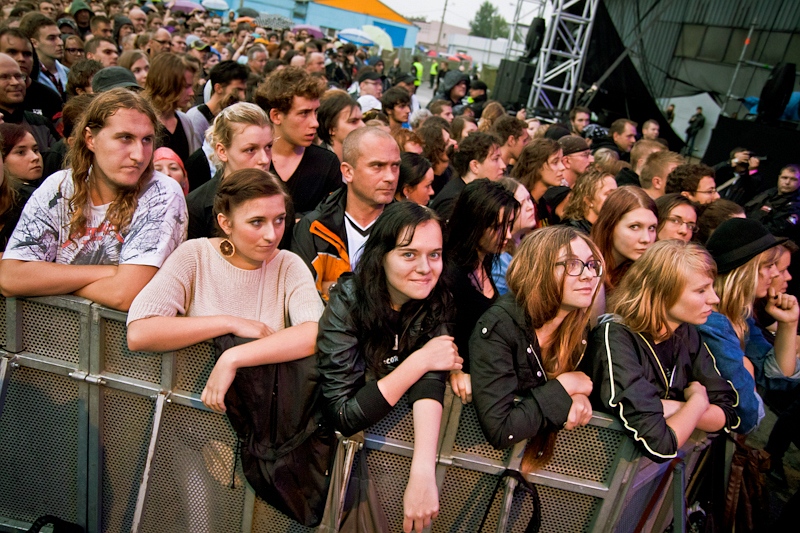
[317,273,451,436]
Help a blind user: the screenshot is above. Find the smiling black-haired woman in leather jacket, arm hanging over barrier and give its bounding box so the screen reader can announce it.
[317,202,462,532]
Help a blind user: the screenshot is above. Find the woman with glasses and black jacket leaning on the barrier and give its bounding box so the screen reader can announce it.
[469,226,603,472]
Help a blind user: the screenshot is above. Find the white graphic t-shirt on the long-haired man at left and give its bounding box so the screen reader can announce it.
[3,170,188,267]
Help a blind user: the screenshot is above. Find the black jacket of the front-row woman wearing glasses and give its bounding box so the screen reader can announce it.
[469,293,572,449]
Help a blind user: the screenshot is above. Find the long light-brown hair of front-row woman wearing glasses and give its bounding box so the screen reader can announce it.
[506,226,603,473]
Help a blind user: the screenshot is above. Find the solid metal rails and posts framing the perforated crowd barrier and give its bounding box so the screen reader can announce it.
[0,296,702,533]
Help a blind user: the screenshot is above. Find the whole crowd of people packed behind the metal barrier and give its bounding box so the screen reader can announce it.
[0,0,800,531]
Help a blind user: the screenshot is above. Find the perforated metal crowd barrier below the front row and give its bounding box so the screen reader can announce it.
[0,296,708,533]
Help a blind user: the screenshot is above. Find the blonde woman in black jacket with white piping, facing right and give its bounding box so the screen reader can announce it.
[585,239,740,462]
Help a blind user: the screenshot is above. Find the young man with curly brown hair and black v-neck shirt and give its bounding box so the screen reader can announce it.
[255,67,342,248]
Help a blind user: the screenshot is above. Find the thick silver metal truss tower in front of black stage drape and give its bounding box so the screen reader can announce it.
[518,0,599,114]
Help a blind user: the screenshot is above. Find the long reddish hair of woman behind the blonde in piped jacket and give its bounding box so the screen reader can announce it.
[592,185,658,291]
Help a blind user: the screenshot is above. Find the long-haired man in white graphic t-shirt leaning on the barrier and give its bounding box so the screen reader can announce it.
[0,89,187,310]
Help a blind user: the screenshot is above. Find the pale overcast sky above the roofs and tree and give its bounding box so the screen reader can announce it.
[381,0,536,28]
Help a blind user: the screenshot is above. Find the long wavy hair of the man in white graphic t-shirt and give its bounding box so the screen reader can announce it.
[66,89,158,239]
